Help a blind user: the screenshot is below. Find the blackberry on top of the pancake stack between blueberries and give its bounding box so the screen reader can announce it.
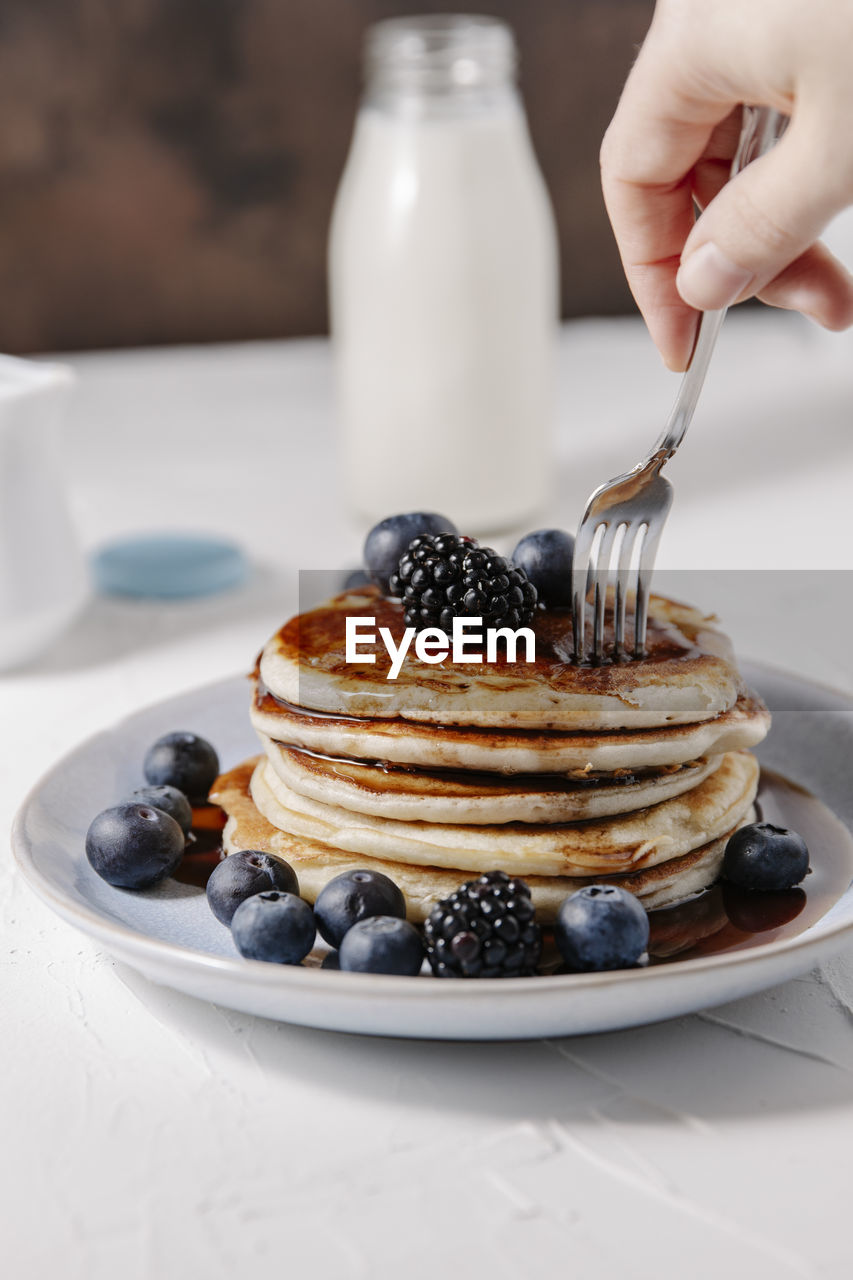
[389,534,537,632]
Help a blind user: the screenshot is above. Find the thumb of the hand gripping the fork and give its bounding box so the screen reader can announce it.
[675,119,849,311]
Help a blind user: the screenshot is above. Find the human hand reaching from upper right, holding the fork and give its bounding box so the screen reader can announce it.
[601,0,853,369]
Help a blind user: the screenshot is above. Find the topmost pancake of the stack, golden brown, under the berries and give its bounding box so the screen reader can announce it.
[260,586,739,732]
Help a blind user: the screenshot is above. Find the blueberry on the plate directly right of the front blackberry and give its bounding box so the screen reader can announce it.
[553,884,649,972]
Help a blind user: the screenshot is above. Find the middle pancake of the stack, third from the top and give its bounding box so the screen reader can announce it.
[261,739,721,826]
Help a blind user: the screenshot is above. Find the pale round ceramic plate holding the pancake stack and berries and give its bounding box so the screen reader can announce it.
[13,667,853,1039]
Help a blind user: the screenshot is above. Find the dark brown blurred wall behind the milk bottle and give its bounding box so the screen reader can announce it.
[0,0,653,352]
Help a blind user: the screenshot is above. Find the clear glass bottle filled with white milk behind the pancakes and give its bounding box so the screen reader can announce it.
[329,15,558,532]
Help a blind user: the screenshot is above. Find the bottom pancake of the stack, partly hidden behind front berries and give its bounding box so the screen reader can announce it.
[211,760,731,924]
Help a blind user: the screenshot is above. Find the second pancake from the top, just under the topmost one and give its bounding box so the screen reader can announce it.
[250,678,770,773]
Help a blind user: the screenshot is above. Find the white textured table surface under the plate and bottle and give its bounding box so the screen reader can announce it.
[0,312,853,1280]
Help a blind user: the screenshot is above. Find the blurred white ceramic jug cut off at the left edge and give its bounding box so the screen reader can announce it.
[0,356,88,667]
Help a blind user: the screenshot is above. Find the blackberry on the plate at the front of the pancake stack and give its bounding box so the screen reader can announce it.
[424,872,542,978]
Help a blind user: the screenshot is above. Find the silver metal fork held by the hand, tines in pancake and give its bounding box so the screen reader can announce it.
[571,106,788,663]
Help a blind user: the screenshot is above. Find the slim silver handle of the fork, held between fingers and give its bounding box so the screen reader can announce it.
[646,106,788,466]
